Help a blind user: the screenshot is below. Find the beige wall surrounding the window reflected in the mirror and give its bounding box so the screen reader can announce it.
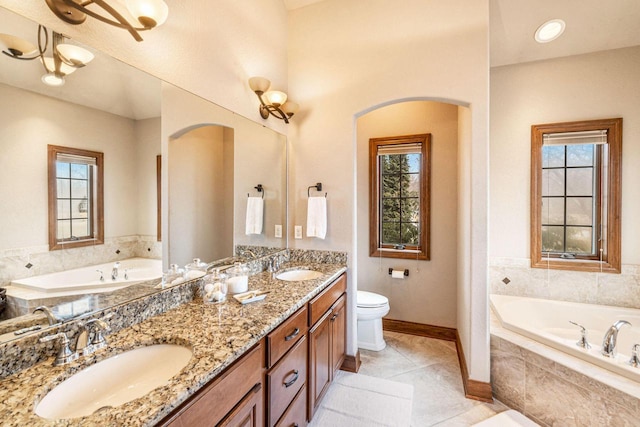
[0,85,160,252]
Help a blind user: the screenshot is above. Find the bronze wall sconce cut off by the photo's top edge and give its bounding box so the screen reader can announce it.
[45,0,169,42]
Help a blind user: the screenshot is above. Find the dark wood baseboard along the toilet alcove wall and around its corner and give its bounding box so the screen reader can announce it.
[382,319,493,402]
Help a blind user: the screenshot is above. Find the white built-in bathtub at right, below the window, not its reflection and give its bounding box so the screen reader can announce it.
[490,295,640,382]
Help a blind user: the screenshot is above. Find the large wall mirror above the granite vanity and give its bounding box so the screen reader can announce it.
[0,7,287,342]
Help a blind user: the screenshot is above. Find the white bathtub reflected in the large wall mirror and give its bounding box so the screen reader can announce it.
[11,258,162,295]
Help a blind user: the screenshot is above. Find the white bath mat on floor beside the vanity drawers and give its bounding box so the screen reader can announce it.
[309,371,413,427]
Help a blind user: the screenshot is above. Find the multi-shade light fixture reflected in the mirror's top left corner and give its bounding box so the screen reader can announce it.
[0,25,94,86]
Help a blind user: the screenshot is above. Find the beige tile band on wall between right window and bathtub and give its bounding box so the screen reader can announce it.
[489,257,640,308]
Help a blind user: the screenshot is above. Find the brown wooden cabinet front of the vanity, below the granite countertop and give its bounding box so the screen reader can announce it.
[160,273,347,427]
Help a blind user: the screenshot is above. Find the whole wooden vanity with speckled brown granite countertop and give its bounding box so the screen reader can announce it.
[0,263,346,426]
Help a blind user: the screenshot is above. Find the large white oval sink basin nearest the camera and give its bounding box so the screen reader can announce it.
[35,344,193,420]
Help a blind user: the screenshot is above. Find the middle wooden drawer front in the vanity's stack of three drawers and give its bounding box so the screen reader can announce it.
[267,337,307,426]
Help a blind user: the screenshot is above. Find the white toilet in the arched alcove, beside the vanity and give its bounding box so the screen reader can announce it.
[356,291,389,351]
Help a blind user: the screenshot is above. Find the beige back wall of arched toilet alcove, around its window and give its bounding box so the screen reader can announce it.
[357,101,458,328]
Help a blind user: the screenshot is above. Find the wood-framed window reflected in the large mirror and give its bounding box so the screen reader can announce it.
[48,145,104,250]
